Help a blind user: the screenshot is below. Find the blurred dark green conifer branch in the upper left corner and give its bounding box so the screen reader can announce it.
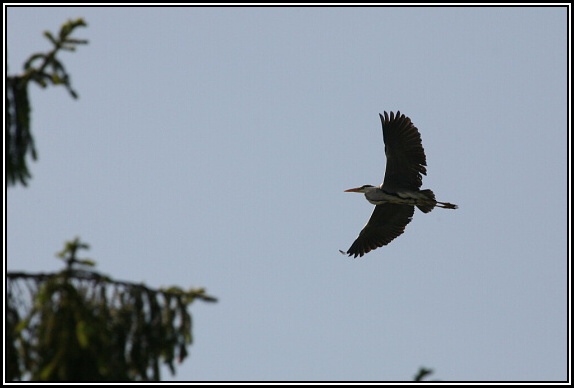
[4,19,87,186]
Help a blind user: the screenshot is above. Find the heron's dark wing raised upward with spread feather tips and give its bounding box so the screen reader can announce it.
[379,112,427,192]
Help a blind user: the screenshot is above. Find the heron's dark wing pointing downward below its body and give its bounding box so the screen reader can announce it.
[347,203,415,257]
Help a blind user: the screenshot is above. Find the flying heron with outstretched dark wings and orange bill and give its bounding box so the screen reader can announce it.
[341,112,458,257]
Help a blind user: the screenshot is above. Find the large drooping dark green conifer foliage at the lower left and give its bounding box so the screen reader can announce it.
[5,239,216,381]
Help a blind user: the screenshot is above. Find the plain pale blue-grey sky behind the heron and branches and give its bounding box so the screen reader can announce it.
[6,6,568,381]
